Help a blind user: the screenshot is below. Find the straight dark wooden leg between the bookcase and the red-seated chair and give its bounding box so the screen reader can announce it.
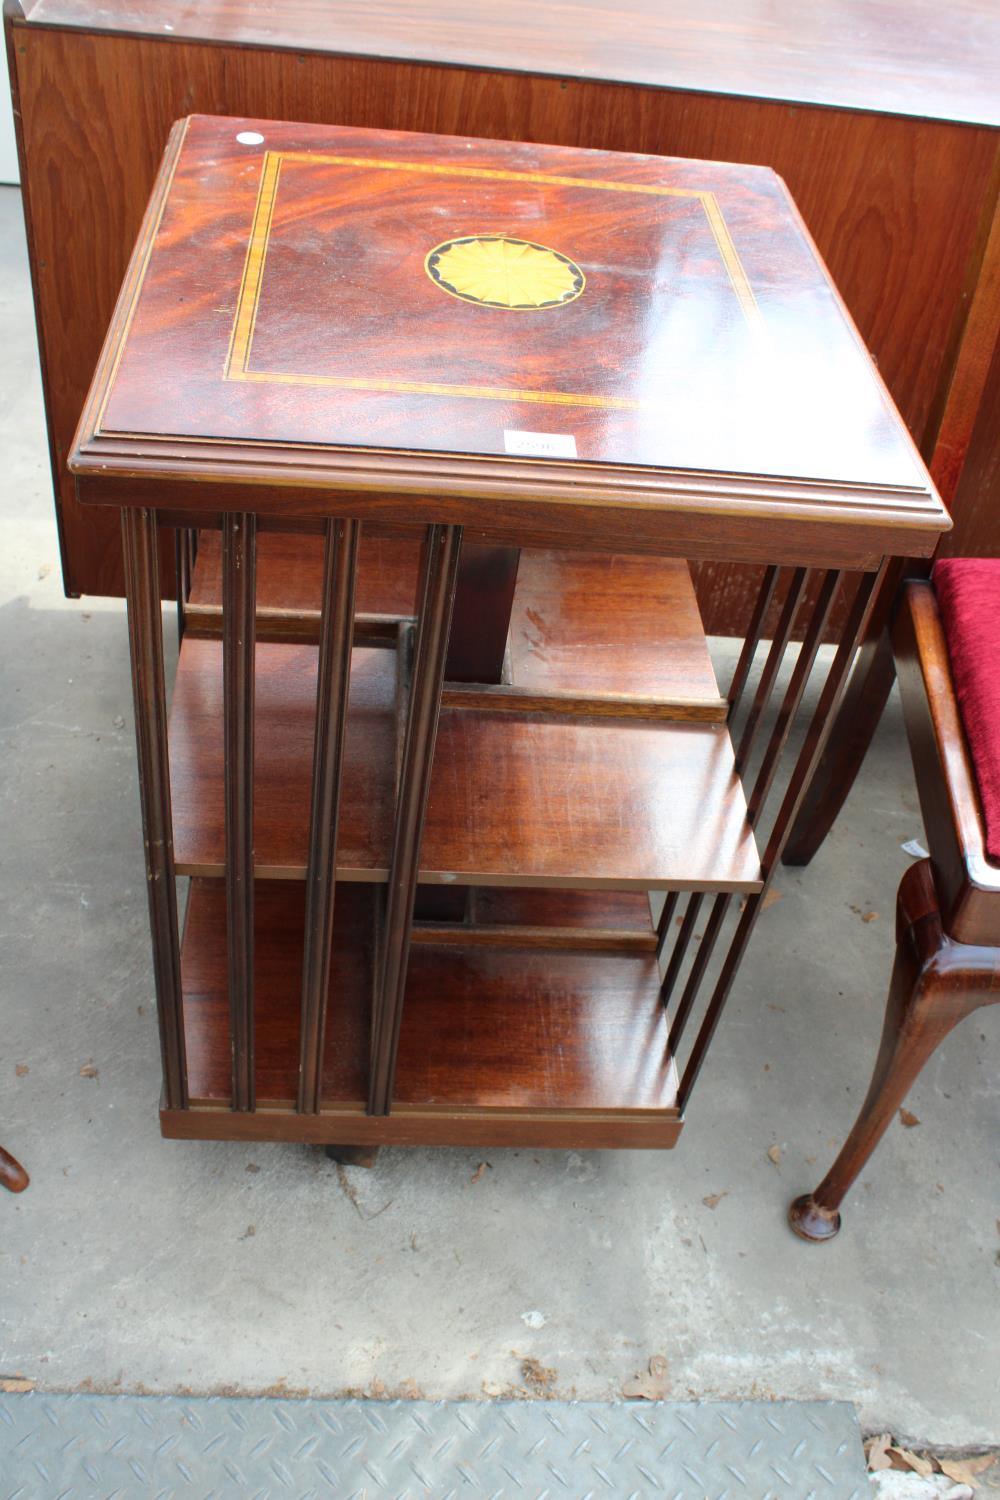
[781,630,897,864]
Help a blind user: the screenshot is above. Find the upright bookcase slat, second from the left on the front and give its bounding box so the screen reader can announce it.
[222,513,256,1110]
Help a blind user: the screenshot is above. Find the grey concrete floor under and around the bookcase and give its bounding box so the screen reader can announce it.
[0,178,1000,1446]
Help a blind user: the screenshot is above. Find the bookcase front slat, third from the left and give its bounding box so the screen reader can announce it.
[298,521,361,1115]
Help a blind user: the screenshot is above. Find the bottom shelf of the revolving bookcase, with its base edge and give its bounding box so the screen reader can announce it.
[176,879,681,1146]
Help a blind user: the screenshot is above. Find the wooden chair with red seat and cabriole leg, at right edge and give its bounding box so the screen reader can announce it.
[789,558,1000,1241]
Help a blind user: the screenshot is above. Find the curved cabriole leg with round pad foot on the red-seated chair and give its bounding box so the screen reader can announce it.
[789,860,1000,1241]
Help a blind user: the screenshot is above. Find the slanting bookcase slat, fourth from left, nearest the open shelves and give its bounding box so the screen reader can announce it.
[369,525,462,1115]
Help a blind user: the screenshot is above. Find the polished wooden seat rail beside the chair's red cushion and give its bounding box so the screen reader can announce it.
[892,581,1000,945]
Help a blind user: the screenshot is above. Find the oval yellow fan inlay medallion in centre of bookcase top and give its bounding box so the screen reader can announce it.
[424,234,586,312]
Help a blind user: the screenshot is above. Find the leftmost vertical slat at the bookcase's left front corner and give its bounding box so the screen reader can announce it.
[121,509,187,1110]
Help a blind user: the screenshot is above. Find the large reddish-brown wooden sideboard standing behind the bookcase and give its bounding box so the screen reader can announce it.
[6,0,1000,633]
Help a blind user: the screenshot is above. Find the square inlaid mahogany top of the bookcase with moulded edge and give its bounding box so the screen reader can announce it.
[72,116,948,555]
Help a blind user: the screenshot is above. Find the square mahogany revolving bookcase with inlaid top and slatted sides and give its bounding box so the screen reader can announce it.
[70,116,949,1146]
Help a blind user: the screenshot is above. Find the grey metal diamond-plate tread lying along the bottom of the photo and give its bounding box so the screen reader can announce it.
[0,1392,870,1500]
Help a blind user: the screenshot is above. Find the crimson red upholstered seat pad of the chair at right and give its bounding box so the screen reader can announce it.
[934,558,1000,864]
